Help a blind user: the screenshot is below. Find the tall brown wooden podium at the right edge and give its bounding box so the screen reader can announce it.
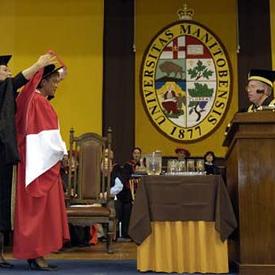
[223,111,275,275]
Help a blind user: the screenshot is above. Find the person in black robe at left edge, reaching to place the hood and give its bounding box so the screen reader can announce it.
[0,53,55,268]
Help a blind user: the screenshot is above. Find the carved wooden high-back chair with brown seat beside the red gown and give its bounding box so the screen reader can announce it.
[66,129,116,253]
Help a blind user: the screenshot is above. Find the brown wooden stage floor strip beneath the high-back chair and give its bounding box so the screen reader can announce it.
[4,242,136,260]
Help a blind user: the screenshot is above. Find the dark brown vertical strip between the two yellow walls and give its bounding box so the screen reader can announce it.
[102,0,135,164]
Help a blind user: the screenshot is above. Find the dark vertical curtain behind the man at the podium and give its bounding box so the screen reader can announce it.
[238,0,272,111]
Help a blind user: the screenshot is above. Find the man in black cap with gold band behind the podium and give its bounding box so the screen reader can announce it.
[246,70,275,112]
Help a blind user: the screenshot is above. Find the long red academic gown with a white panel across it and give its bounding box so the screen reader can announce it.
[13,72,69,259]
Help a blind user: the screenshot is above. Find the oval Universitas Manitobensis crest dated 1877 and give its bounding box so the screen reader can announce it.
[141,6,232,142]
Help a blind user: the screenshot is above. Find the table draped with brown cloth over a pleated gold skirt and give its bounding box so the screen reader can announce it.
[129,175,237,273]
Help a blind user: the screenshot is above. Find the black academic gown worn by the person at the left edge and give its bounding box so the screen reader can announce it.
[0,73,27,231]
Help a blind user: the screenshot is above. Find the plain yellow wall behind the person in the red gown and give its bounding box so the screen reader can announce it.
[0,0,104,146]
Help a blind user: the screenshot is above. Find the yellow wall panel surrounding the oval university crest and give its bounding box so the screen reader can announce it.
[135,0,238,157]
